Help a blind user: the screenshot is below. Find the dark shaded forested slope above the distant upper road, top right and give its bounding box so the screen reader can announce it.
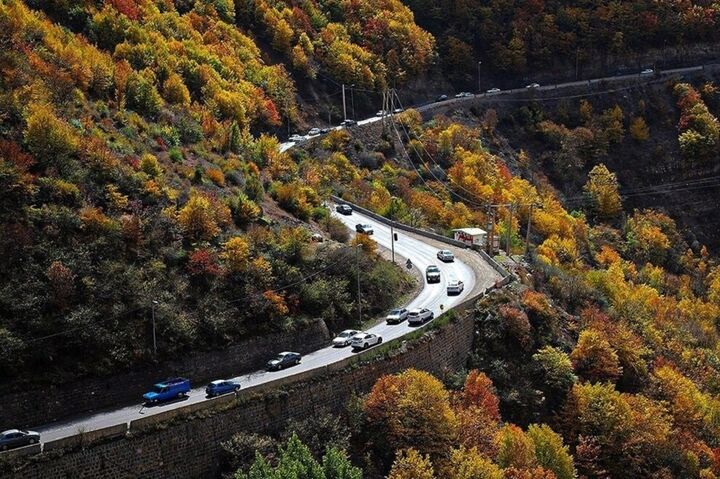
[407,0,720,79]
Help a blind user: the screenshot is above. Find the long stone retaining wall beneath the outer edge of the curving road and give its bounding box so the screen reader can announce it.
[0,300,474,479]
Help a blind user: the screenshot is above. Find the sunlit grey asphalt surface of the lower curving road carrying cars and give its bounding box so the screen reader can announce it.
[33,211,500,442]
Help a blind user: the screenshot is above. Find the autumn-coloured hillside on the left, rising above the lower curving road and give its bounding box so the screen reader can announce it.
[0,1,416,382]
